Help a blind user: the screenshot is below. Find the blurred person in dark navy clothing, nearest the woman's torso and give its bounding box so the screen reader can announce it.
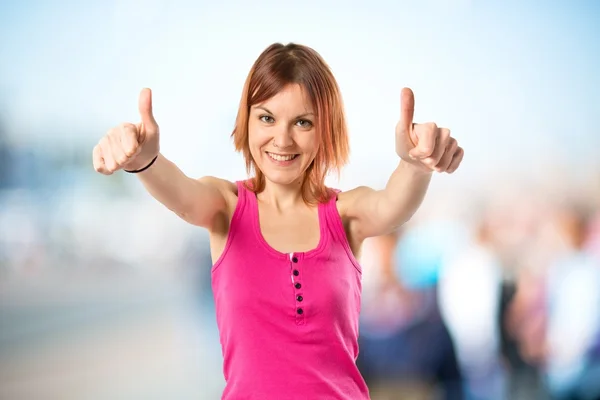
[358,232,464,400]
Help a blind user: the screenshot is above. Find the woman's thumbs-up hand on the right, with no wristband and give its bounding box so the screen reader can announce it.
[396,88,464,174]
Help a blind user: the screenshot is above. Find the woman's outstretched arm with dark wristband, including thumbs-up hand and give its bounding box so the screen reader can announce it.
[93,89,233,229]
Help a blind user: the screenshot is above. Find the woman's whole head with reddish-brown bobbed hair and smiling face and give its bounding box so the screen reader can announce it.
[232,44,349,203]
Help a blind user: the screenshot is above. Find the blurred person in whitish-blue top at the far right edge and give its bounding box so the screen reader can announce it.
[544,205,600,400]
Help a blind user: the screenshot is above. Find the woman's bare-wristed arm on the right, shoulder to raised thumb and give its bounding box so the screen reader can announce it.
[339,88,464,241]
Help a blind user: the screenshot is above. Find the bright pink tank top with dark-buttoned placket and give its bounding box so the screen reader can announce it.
[212,182,369,400]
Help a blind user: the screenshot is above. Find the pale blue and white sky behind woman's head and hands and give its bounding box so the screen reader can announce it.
[0,0,600,185]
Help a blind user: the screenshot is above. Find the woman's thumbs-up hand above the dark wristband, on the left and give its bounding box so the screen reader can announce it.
[93,89,160,175]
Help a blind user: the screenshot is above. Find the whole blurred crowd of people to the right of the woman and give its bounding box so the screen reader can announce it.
[359,183,600,400]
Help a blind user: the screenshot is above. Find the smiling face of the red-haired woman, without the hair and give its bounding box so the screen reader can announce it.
[248,84,319,185]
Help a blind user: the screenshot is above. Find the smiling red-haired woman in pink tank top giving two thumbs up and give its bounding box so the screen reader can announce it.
[93,43,463,400]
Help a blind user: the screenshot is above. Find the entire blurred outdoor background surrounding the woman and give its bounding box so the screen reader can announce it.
[0,0,600,400]
